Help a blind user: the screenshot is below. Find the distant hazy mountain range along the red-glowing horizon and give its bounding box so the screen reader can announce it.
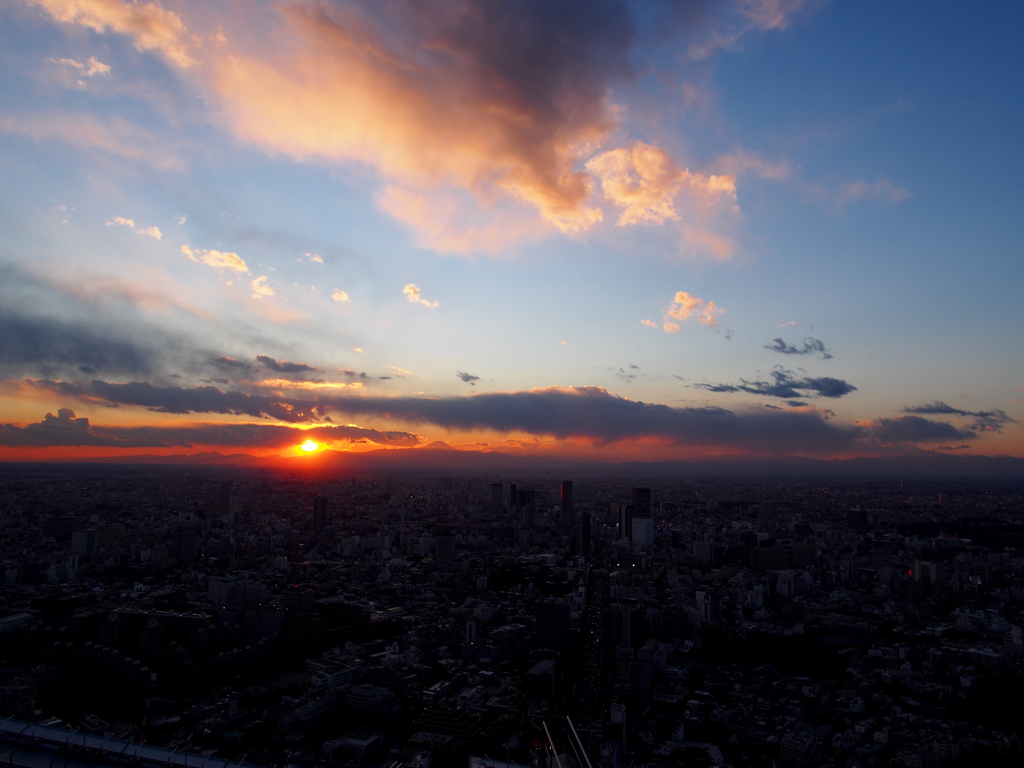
[4,440,1024,480]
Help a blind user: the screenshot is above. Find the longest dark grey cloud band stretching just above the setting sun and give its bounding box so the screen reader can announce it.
[22,381,865,453]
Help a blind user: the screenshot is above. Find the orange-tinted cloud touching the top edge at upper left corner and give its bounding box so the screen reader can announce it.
[29,0,196,68]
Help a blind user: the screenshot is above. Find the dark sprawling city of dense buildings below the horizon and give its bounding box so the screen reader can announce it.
[0,465,1024,768]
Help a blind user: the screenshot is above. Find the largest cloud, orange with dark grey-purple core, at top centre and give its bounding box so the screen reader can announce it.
[194,0,634,246]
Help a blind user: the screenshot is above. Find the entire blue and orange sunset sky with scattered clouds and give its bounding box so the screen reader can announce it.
[0,0,1024,462]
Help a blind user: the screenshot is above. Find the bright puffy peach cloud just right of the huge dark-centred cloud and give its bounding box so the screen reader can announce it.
[586,141,736,226]
